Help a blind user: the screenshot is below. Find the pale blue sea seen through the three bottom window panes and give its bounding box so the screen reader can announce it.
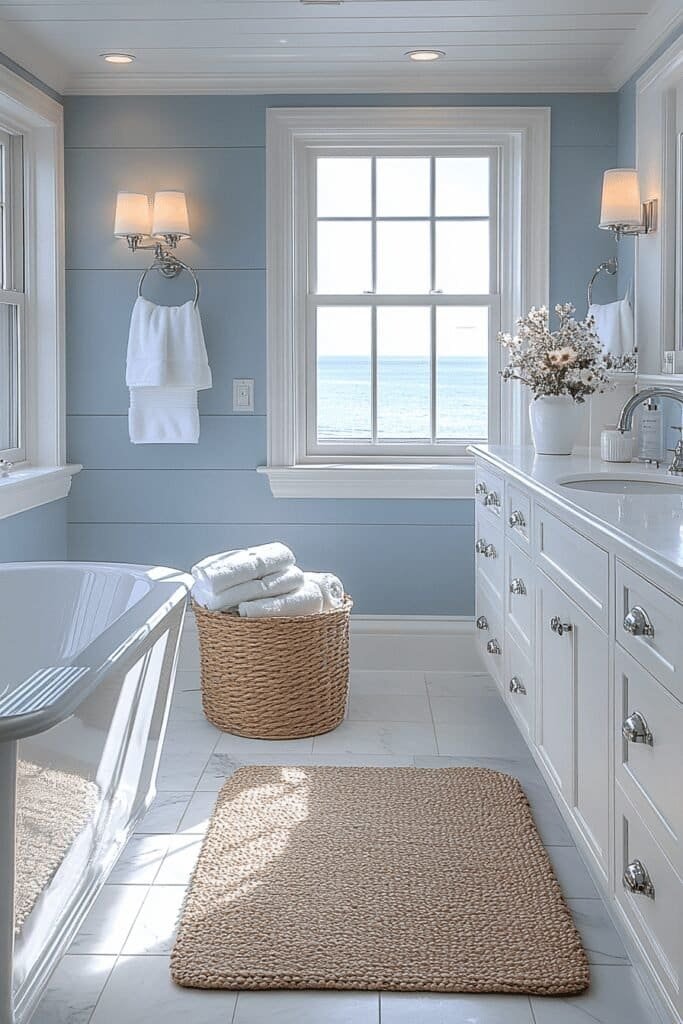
[317,356,488,441]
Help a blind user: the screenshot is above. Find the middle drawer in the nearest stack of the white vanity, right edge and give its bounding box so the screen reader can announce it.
[614,649,683,870]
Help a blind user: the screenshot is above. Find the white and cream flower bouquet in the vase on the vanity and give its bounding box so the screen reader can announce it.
[498,302,613,401]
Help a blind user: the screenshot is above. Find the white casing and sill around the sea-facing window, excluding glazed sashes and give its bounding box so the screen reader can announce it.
[260,106,550,498]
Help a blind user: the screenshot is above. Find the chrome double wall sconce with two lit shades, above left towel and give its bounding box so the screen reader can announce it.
[114,191,191,278]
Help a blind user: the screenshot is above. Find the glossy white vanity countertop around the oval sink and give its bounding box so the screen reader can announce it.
[472,444,683,575]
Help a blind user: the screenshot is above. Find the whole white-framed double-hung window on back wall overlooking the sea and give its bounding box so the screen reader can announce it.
[264,108,550,497]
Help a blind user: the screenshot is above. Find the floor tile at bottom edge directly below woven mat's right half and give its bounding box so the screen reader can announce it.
[381,992,533,1024]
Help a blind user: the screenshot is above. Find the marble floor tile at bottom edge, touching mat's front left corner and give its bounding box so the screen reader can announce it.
[91,956,232,1024]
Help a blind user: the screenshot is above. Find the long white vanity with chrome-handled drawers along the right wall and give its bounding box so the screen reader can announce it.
[474,449,683,1024]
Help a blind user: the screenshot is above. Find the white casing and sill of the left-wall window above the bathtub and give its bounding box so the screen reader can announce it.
[0,68,80,519]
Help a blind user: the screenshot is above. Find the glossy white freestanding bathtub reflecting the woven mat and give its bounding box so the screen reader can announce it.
[0,562,191,1024]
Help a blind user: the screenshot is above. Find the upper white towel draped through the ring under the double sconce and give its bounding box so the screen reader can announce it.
[126,297,211,390]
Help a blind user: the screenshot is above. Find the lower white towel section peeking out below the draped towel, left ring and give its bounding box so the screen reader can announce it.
[128,387,200,444]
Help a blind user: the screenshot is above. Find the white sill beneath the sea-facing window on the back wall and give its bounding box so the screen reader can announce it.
[257,461,474,499]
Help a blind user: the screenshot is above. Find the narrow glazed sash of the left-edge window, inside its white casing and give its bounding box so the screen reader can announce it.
[0,129,26,462]
